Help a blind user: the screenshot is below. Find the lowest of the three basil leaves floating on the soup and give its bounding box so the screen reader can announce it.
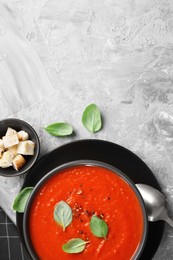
[62,238,89,254]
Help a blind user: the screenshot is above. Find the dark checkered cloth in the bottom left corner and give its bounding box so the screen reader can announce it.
[0,208,30,260]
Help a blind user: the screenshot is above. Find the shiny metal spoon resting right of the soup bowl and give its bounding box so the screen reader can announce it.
[136,184,173,227]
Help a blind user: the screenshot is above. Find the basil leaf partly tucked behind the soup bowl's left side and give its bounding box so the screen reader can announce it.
[13,187,34,213]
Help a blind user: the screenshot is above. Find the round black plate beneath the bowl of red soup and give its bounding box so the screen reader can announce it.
[16,140,164,260]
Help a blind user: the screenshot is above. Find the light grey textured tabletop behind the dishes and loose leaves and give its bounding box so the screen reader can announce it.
[0,0,173,260]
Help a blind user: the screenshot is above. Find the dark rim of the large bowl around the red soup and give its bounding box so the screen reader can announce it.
[23,160,148,260]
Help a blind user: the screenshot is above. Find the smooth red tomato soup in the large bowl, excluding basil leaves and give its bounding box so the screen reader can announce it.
[29,165,144,260]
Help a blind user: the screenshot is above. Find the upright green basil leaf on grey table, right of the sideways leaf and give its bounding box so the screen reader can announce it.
[82,104,102,133]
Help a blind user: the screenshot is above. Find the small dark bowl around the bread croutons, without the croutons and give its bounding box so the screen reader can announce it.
[0,118,40,177]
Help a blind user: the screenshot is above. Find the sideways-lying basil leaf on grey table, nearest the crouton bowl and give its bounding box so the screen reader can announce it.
[44,123,73,136]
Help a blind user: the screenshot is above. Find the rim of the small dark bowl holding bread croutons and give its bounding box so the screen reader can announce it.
[0,118,40,177]
